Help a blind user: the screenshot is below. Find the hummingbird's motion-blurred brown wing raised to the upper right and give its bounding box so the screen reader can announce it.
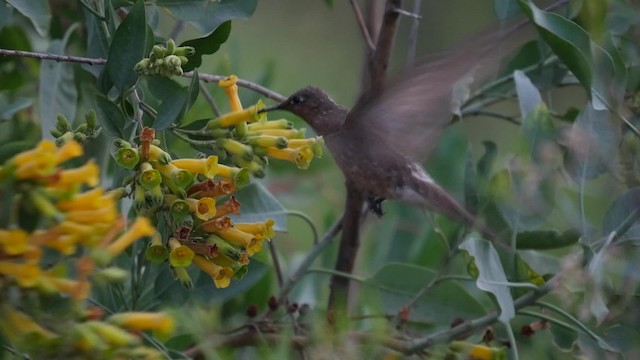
[343,23,520,160]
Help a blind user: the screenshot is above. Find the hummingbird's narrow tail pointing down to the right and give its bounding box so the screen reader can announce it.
[399,164,496,240]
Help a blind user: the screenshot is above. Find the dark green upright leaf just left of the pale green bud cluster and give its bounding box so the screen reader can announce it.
[107,0,147,91]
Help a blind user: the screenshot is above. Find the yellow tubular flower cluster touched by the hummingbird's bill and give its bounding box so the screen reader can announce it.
[201,75,323,177]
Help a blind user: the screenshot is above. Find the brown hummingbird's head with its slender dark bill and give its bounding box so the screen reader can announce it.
[264,86,347,135]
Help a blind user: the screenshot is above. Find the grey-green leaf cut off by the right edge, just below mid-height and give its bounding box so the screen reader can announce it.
[602,188,640,244]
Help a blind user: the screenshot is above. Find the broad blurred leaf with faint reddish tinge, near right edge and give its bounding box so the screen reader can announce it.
[564,103,621,183]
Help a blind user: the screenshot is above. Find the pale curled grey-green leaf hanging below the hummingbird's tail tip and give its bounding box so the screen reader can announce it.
[460,236,515,322]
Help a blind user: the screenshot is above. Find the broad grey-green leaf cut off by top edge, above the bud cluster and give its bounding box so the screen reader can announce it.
[156,0,258,34]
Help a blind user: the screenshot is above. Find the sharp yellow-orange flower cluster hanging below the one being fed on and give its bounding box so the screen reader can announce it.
[115,128,274,288]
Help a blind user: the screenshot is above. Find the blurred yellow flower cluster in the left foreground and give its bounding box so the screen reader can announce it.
[0,140,173,359]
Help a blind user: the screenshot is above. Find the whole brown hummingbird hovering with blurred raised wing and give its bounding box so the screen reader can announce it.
[264,27,524,238]
